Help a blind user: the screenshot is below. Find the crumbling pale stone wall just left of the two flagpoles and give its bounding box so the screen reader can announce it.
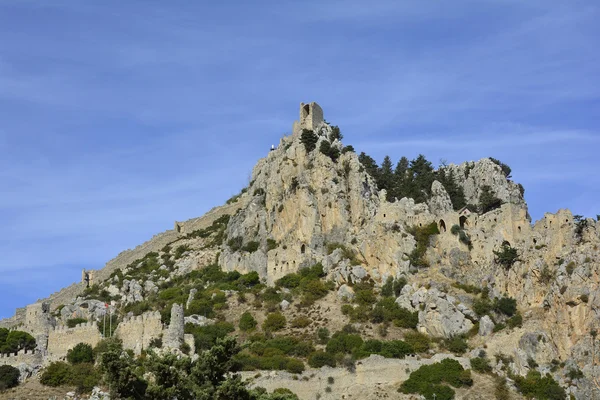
[48,322,102,360]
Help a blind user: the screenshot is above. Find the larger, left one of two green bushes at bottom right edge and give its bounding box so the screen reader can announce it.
[398,358,473,400]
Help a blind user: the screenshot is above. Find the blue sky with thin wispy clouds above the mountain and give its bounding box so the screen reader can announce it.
[0,0,600,317]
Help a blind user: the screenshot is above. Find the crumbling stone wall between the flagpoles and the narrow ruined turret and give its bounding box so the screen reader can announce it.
[115,311,163,354]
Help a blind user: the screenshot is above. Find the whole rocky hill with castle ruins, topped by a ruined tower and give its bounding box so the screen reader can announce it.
[0,103,600,399]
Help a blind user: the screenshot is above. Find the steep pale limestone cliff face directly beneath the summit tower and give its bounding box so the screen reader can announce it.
[219,119,432,282]
